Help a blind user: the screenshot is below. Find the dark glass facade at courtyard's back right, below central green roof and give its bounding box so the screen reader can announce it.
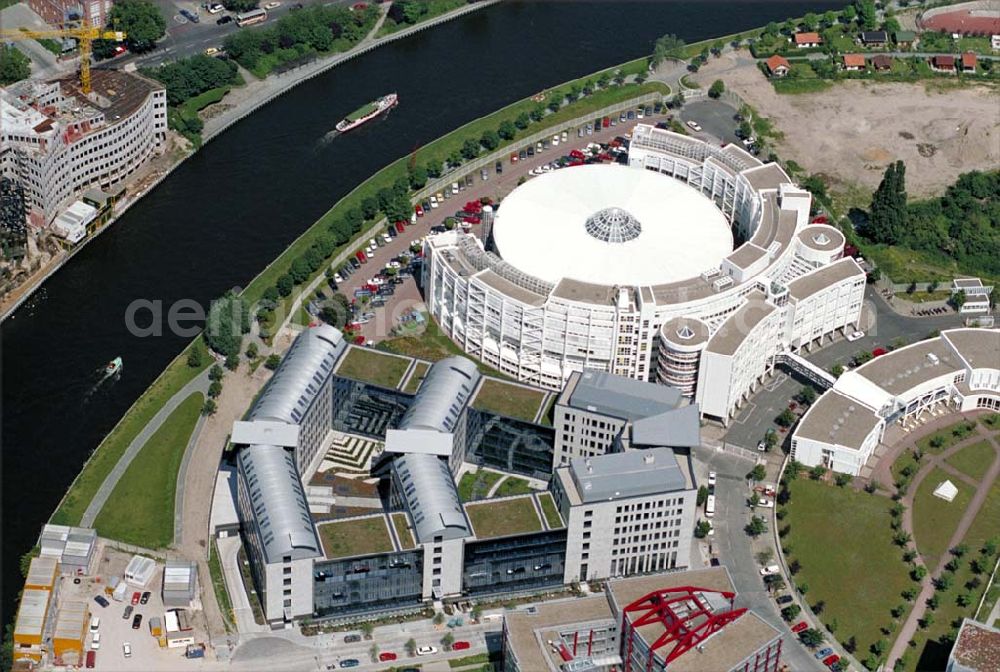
[465,407,555,480]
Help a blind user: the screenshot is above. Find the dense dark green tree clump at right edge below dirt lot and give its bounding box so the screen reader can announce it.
[860,167,1000,278]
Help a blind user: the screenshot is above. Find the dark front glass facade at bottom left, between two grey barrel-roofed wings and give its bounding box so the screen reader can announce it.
[313,549,423,616]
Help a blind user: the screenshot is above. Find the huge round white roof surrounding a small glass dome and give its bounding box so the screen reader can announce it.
[493,165,733,285]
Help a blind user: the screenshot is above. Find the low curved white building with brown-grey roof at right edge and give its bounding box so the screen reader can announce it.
[791,329,1000,476]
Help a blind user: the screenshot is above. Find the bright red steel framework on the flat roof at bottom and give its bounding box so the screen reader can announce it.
[621,586,747,672]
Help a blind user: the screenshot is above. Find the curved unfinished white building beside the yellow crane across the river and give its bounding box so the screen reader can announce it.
[0,70,167,226]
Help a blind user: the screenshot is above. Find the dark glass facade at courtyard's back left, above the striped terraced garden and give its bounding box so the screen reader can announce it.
[332,375,413,441]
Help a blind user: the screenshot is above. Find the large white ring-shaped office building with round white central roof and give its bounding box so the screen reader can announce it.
[424,124,864,419]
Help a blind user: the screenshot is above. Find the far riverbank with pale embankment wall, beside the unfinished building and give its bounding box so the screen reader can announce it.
[0,0,503,322]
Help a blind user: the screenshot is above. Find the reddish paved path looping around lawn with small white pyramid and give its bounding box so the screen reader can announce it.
[886,424,1000,669]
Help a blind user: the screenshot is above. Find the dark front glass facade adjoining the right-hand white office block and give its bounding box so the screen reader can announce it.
[462,529,566,595]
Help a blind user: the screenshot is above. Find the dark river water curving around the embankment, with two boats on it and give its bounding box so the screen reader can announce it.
[0,0,843,623]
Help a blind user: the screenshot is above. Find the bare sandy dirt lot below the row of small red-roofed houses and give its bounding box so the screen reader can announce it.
[694,51,1000,196]
